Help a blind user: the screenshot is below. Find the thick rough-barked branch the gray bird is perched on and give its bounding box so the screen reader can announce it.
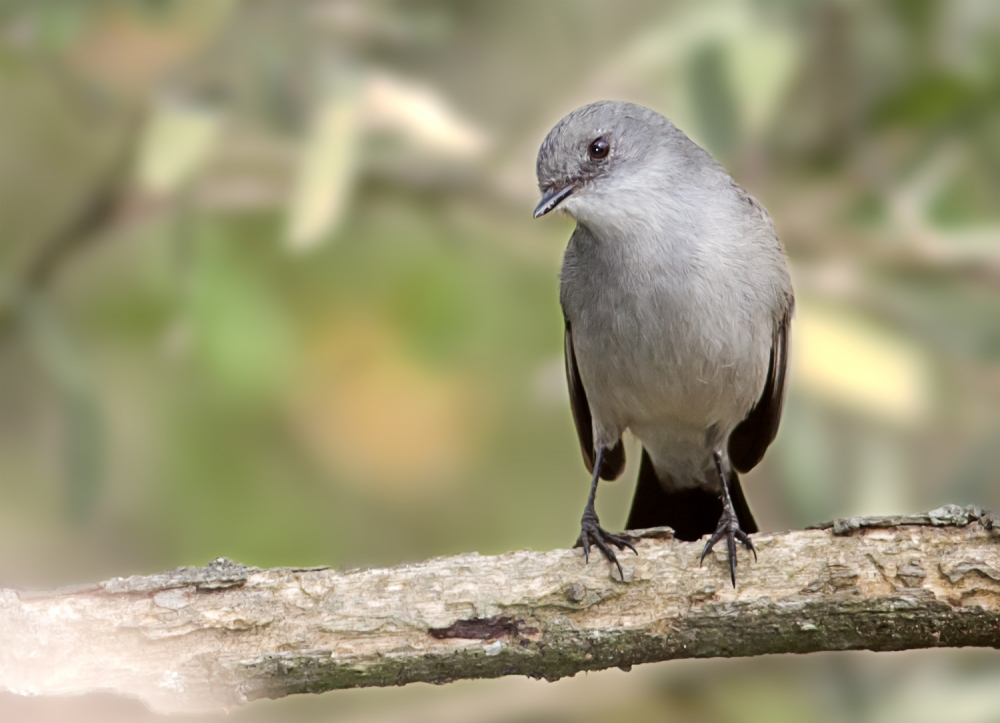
[0,506,1000,712]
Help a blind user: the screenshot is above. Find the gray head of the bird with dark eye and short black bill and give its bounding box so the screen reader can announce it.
[535,101,680,220]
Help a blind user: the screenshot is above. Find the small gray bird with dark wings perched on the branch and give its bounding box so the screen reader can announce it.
[535,101,794,586]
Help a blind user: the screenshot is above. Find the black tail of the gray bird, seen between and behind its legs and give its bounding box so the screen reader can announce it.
[626,449,757,541]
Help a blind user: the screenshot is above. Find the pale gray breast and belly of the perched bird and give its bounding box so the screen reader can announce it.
[562,189,784,467]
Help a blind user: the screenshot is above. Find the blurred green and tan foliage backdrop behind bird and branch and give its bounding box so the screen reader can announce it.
[0,0,1000,723]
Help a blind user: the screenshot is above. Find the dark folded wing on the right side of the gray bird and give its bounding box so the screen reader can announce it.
[729,300,793,472]
